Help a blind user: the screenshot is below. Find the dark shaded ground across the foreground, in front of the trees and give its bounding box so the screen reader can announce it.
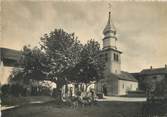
[2,101,142,117]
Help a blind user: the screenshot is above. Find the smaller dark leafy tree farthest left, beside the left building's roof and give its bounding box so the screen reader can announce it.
[18,46,48,80]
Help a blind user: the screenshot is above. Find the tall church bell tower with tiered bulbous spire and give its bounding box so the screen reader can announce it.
[103,11,122,74]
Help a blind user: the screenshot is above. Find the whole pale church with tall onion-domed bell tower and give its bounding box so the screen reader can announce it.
[96,12,138,96]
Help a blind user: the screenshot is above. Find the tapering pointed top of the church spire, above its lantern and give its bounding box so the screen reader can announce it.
[103,12,116,34]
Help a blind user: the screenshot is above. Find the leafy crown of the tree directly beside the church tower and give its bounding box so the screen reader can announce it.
[81,40,105,80]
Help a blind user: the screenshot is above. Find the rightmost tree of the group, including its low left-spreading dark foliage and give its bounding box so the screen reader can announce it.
[66,40,104,88]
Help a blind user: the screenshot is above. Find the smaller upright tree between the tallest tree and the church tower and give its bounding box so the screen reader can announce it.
[80,39,105,82]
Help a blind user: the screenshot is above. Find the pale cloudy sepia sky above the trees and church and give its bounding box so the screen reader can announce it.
[0,0,167,72]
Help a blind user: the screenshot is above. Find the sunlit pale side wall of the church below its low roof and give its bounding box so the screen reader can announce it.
[118,80,138,95]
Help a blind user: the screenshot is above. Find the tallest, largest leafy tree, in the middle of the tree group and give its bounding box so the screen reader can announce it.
[41,29,82,87]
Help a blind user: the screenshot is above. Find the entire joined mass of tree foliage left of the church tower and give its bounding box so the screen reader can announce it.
[10,29,104,87]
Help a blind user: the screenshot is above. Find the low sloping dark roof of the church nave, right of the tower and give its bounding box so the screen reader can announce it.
[109,71,137,82]
